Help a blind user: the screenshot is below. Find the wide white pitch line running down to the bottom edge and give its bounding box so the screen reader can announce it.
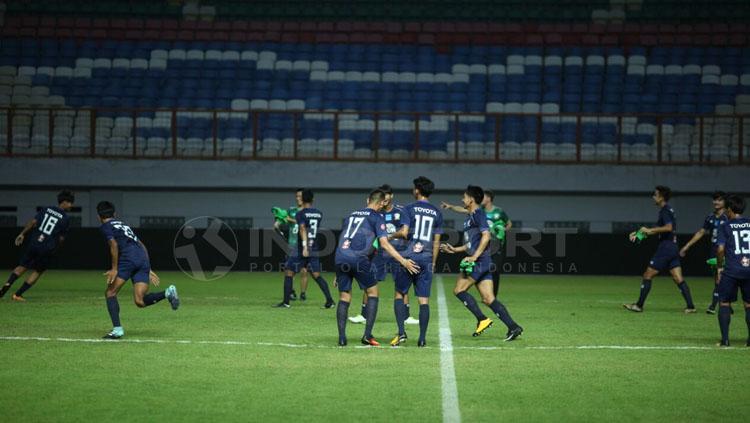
[437,276,461,423]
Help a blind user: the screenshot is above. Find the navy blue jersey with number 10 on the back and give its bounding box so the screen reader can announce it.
[404,200,444,263]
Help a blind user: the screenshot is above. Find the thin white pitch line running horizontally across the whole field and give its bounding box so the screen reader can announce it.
[0,336,750,351]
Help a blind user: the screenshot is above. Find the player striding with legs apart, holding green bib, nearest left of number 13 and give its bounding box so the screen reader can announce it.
[623,185,695,313]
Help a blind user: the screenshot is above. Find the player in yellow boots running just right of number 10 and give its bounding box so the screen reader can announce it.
[442,185,523,341]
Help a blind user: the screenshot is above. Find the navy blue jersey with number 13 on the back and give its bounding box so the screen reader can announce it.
[717,217,750,279]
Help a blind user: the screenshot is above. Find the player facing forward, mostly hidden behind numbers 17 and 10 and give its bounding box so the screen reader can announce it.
[349,184,419,325]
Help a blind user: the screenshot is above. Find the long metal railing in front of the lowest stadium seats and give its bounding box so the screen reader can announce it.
[0,107,750,165]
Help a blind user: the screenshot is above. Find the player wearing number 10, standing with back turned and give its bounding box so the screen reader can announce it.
[391,176,443,347]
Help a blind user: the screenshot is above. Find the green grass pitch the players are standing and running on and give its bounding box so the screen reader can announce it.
[0,271,750,421]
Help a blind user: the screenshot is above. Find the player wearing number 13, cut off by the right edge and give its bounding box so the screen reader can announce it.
[716,195,750,347]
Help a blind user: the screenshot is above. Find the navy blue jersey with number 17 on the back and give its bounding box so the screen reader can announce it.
[336,208,388,263]
